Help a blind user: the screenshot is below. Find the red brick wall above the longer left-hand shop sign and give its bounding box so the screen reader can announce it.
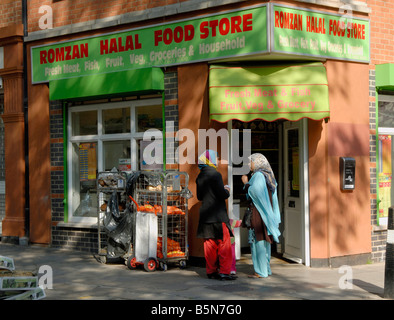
[26,0,186,32]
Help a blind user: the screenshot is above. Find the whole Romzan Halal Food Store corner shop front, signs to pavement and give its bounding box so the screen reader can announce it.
[0,2,371,266]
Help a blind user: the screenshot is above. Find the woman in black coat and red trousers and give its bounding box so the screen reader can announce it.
[196,150,234,280]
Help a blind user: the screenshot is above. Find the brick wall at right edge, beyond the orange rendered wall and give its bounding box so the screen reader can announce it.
[366,0,394,262]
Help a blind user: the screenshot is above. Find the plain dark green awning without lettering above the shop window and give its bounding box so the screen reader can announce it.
[49,68,164,100]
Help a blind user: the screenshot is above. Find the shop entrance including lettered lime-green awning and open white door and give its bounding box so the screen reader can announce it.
[209,62,330,263]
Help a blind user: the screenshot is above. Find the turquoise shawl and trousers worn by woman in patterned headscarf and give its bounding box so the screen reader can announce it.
[247,172,281,277]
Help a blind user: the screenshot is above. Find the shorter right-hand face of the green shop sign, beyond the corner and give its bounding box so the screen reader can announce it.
[271,5,370,62]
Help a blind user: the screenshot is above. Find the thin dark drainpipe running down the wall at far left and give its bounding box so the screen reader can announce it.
[19,0,30,245]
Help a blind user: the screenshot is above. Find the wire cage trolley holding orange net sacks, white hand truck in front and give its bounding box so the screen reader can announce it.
[126,171,191,271]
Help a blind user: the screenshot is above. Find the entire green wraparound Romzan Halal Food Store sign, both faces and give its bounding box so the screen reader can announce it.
[31,3,370,83]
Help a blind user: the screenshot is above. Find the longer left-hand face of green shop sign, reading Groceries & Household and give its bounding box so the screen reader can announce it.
[31,5,268,83]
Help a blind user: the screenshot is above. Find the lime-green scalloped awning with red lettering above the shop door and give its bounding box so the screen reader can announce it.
[209,63,330,122]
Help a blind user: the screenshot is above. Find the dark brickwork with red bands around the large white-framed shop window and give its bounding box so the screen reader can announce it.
[50,68,178,253]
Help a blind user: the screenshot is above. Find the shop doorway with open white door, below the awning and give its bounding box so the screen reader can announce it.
[229,120,309,265]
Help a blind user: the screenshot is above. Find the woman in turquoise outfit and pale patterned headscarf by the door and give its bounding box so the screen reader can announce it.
[242,153,280,278]
